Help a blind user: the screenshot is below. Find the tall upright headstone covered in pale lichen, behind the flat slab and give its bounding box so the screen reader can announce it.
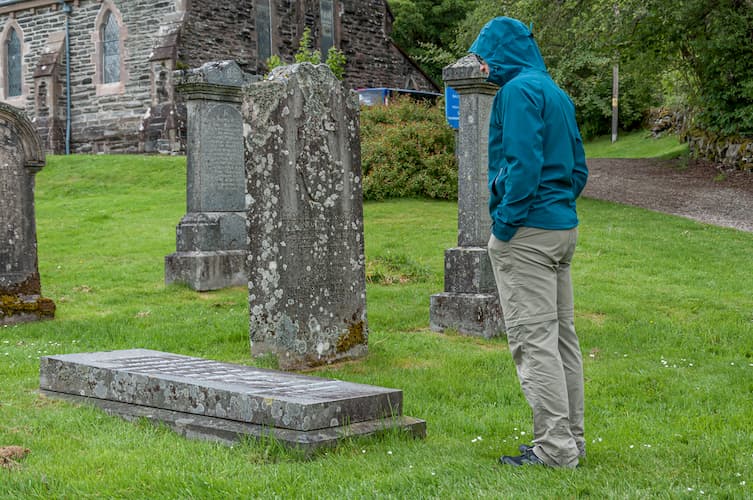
[242,63,367,369]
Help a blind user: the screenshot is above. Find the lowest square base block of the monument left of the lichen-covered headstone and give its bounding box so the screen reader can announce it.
[165,250,248,292]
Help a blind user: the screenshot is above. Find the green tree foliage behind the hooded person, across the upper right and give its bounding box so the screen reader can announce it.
[391,0,753,141]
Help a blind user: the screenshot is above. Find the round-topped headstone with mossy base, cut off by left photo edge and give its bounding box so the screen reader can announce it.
[0,103,55,325]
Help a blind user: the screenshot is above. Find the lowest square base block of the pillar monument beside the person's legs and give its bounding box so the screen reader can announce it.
[429,292,505,338]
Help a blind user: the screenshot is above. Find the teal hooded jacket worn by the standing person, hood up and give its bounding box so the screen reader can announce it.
[469,17,588,241]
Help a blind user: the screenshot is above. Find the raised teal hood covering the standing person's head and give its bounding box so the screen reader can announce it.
[468,17,546,86]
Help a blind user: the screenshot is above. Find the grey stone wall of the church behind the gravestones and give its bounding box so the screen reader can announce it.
[0,0,437,153]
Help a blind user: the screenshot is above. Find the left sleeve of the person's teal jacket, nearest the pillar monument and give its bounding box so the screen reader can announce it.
[492,82,544,241]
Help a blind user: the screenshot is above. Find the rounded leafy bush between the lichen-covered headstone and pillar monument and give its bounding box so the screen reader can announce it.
[361,97,458,200]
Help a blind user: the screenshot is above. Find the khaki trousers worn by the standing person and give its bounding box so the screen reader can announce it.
[488,227,585,467]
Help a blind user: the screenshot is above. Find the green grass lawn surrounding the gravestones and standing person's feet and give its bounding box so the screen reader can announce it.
[0,146,753,499]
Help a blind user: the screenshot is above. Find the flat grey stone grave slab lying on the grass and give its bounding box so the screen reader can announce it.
[39,349,426,450]
